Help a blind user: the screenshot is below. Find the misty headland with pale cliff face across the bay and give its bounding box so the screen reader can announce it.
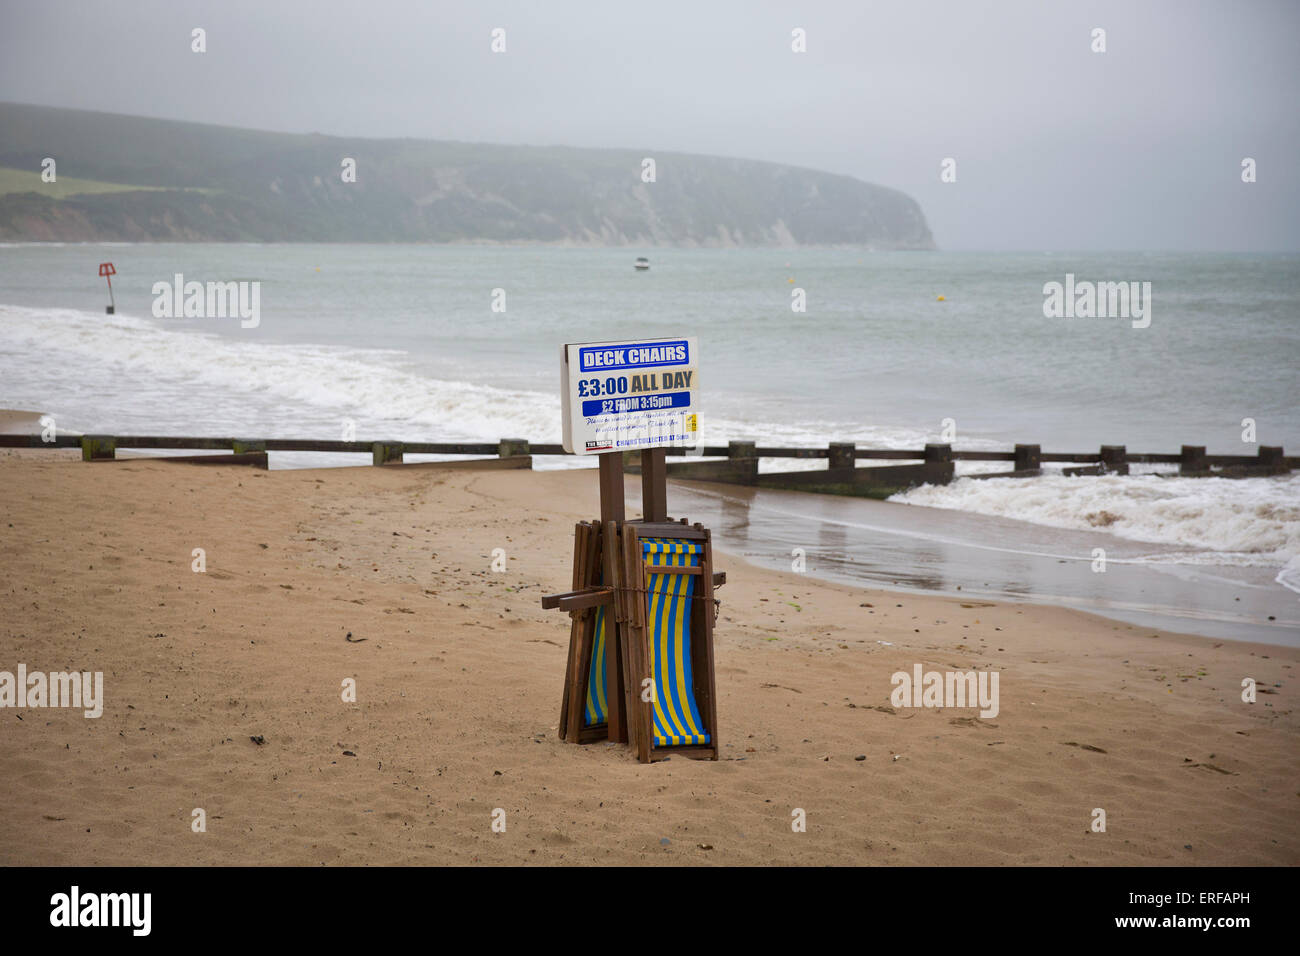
[0,104,933,248]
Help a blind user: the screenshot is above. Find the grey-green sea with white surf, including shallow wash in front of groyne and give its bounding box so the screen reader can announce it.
[0,243,1300,645]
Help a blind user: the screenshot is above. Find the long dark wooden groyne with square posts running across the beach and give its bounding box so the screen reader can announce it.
[0,434,1300,498]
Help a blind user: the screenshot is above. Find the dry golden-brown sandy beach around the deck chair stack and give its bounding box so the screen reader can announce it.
[0,450,1300,866]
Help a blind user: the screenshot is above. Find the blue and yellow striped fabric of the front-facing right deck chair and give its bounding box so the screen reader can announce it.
[641,537,710,747]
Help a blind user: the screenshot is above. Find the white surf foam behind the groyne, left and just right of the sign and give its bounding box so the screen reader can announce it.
[0,306,993,471]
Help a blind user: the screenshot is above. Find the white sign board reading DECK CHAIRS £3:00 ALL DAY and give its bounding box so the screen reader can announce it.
[560,336,699,455]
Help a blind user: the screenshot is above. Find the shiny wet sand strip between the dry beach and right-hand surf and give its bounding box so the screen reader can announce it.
[675,481,1300,648]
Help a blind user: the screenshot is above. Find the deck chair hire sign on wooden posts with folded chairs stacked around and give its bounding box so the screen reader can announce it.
[542,336,725,761]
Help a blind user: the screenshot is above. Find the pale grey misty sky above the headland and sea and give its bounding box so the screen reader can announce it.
[0,0,1300,250]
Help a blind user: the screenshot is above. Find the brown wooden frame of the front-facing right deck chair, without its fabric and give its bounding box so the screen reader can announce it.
[615,522,719,763]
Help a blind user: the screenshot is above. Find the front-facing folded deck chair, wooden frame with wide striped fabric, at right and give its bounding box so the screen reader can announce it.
[620,523,718,762]
